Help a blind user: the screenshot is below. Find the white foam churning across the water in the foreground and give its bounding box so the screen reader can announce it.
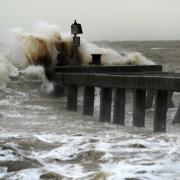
[0,129,180,180]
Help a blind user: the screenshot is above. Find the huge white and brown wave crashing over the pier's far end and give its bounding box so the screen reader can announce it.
[0,22,155,89]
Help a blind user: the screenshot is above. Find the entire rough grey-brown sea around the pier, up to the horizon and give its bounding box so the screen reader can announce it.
[0,23,180,180]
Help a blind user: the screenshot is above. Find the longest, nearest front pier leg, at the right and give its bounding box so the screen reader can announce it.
[154,90,168,132]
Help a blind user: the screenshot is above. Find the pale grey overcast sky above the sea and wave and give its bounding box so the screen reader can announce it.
[0,0,180,40]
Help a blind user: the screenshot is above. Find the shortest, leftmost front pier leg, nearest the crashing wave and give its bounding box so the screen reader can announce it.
[67,86,78,111]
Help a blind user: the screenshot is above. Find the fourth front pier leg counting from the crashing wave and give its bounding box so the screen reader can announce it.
[113,89,126,126]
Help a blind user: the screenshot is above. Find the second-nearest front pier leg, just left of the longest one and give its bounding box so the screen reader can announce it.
[133,89,146,127]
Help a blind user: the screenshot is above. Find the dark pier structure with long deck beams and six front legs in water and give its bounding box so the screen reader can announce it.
[55,66,180,132]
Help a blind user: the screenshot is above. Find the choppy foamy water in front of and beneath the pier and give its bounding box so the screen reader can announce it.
[0,39,180,180]
